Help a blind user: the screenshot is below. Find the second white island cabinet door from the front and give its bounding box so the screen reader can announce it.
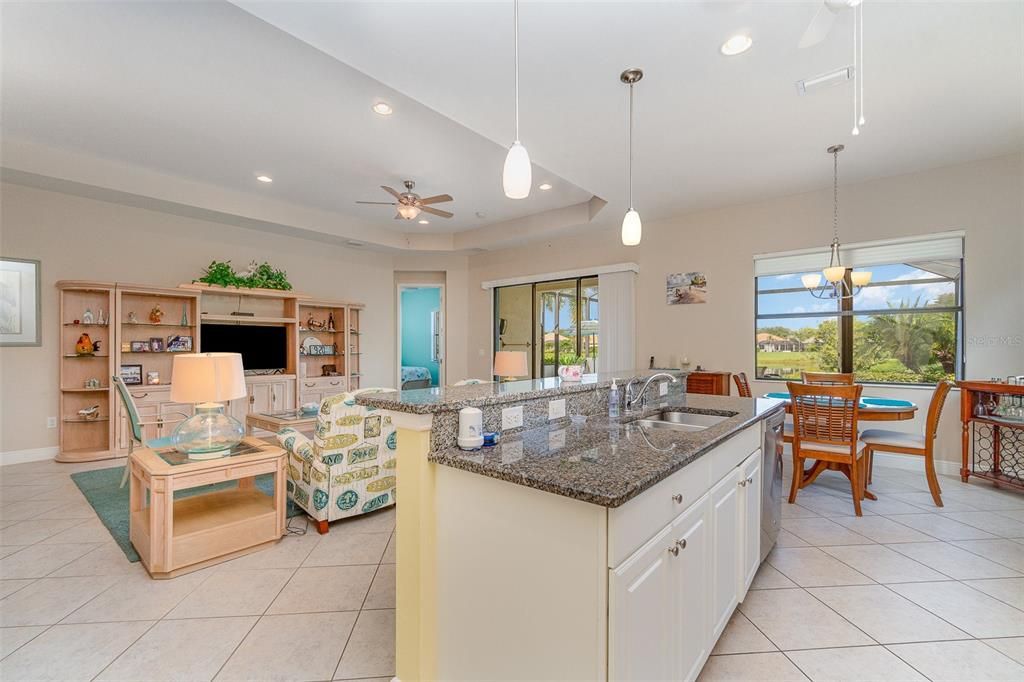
[670,496,714,680]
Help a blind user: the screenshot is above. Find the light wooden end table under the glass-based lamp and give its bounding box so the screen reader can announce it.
[128,437,288,579]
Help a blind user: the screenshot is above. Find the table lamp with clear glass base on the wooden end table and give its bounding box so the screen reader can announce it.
[171,353,246,460]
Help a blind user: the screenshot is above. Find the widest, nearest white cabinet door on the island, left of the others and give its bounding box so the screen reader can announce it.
[608,518,681,680]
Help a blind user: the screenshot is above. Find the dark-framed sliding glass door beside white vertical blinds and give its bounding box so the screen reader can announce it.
[495,276,600,378]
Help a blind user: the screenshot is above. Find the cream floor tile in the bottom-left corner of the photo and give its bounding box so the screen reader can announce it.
[0,621,153,681]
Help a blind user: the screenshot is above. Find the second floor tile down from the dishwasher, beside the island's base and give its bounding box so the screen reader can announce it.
[739,590,873,650]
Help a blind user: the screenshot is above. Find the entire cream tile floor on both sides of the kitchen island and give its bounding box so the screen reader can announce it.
[0,450,1024,682]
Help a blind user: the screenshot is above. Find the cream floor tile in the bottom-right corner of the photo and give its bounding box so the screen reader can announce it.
[888,641,1024,682]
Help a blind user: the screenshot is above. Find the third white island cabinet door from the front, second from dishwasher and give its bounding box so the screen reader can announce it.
[711,467,742,639]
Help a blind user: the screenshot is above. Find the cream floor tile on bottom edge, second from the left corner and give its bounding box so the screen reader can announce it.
[96,614,257,682]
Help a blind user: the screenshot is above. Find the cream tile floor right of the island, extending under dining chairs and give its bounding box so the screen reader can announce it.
[699,456,1024,682]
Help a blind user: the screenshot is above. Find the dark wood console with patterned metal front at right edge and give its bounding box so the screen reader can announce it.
[956,381,1024,491]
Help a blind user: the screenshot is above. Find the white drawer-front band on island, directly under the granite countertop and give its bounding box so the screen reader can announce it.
[608,424,761,568]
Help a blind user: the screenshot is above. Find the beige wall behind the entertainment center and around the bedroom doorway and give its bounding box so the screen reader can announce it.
[0,183,466,453]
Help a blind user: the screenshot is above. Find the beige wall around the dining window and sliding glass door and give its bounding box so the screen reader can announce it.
[469,155,1024,460]
